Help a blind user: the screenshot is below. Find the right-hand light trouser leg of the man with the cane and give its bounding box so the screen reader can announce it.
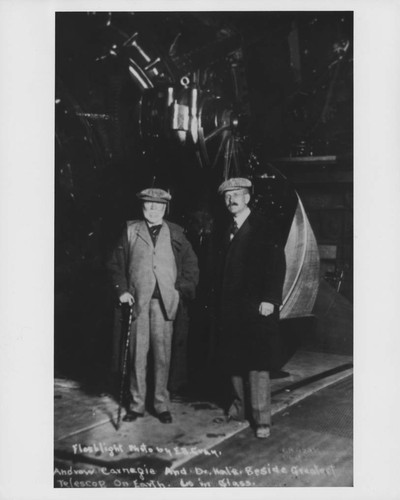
[150,299,173,413]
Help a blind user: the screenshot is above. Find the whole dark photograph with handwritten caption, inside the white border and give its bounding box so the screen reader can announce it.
[53,10,354,489]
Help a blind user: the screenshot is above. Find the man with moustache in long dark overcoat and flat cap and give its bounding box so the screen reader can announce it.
[218,178,286,438]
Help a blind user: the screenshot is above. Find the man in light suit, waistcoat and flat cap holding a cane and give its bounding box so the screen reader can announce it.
[109,188,199,423]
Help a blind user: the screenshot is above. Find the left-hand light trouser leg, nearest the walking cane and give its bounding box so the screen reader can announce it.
[130,308,150,413]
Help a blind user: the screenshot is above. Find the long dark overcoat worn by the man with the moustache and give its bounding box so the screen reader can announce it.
[219,212,286,374]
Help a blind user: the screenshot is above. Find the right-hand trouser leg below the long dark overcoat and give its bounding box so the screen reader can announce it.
[249,371,271,425]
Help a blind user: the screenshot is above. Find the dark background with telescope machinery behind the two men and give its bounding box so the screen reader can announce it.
[54,11,353,396]
